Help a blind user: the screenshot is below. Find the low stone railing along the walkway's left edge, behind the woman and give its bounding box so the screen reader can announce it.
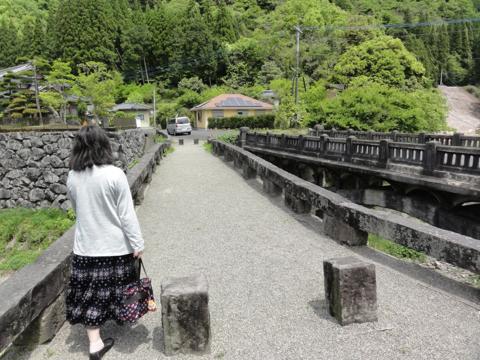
[0,143,170,355]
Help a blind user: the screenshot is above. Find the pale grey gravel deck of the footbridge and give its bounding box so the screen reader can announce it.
[17,144,480,360]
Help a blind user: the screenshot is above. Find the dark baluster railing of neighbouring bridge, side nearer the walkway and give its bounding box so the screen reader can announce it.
[244,129,480,176]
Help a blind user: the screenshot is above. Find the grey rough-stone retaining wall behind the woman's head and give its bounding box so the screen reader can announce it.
[0,129,155,210]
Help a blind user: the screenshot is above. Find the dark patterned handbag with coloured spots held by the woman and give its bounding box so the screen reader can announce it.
[119,258,156,322]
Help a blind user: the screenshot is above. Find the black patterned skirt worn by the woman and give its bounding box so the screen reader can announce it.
[66,254,138,327]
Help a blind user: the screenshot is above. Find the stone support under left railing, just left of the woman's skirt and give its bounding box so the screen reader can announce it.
[14,293,66,346]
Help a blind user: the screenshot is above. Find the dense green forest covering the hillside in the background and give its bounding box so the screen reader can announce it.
[0,0,480,131]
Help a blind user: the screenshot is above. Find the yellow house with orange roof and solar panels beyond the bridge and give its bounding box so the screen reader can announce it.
[190,94,273,129]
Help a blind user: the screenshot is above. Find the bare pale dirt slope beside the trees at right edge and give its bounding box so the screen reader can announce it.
[438,86,480,134]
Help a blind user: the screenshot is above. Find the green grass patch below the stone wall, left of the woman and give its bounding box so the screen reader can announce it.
[0,208,75,271]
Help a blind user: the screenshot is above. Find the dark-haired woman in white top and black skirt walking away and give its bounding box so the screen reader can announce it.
[67,125,144,360]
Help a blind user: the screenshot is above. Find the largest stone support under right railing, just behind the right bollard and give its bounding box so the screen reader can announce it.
[323,214,368,246]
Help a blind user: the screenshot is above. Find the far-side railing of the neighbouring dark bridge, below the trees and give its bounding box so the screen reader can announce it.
[308,125,480,148]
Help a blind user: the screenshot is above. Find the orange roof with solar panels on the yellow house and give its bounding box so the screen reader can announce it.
[191,94,273,111]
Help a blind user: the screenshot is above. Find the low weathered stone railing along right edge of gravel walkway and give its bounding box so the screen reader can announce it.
[212,139,480,273]
